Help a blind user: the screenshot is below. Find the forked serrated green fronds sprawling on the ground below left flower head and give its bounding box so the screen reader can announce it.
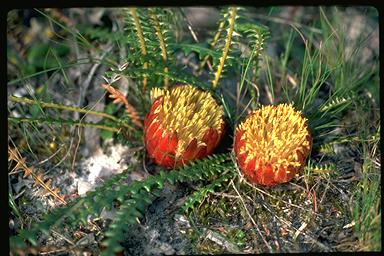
[10,154,231,255]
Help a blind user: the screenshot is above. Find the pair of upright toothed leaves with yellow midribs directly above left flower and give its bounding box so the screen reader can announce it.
[121,8,174,89]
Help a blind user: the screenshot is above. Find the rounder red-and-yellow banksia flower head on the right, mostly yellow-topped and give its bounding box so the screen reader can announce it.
[234,104,312,186]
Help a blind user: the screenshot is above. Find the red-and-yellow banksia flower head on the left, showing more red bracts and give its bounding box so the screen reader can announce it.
[144,85,224,168]
